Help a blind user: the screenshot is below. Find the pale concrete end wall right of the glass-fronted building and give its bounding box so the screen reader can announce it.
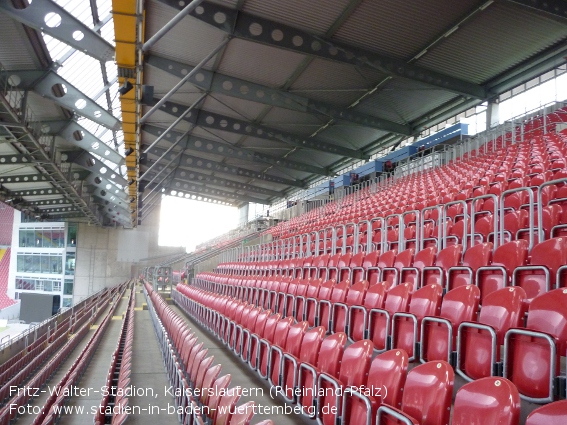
[73,205,180,303]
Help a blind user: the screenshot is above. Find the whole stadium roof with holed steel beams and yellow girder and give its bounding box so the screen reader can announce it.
[0,0,567,226]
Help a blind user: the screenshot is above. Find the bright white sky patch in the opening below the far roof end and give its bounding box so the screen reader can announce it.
[158,196,239,252]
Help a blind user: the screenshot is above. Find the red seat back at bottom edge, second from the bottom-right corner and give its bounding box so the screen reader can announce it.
[451,377,521,425]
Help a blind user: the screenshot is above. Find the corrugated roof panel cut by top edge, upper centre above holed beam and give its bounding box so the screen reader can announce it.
[243,0,350,35]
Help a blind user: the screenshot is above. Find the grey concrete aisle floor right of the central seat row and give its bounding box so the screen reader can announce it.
[171,292,315,425]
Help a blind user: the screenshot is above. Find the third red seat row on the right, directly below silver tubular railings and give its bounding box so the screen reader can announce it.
[209,237,567,302]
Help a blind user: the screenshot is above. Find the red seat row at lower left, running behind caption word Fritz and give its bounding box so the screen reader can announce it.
[0,285,130,425]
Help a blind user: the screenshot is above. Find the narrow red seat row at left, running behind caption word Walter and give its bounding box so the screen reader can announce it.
[32,282,133,425]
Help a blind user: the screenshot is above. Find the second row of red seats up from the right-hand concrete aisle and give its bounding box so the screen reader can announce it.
[189,272,567,402]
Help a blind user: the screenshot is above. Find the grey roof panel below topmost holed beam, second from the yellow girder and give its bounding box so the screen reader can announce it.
[219,38,305,87]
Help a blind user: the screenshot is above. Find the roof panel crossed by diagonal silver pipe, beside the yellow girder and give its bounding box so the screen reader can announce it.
[145,1,226,66]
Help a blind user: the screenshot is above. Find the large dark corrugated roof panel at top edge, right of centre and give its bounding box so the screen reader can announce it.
[333,0,479,60]
